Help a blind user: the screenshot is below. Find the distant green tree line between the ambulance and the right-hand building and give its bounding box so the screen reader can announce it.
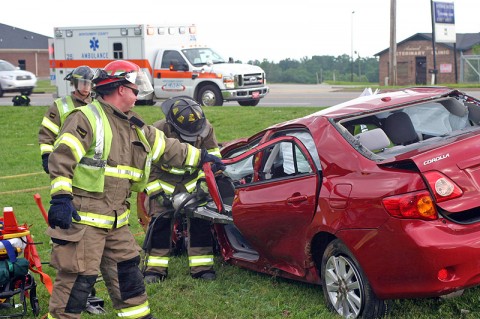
[244,54,378,84]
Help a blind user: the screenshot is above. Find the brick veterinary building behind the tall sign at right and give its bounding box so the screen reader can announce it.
[375,33,480,85]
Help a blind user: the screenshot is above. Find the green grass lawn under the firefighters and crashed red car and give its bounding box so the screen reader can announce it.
[0,106,480,319]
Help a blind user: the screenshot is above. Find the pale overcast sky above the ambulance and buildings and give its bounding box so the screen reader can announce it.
[0,0,472,62]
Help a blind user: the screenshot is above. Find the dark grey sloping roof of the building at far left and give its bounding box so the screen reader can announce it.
[0,23,50,50]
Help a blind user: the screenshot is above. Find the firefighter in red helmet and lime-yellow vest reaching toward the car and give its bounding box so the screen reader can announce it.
[47,60,222,319]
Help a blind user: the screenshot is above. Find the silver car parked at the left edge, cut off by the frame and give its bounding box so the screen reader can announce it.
[0,60,37,97]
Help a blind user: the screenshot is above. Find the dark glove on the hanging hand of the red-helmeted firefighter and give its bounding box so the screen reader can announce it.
[48,195,81,229]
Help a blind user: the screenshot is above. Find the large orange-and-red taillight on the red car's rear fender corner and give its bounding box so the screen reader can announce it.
[383,191,438,220]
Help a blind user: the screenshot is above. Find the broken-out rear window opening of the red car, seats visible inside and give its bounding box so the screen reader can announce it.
[338,96,480,159]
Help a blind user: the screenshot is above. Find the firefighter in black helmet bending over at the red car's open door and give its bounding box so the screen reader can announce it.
[144,96,221,283]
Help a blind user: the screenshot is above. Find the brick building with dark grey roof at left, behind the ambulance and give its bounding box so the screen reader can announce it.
[0,23,50,79]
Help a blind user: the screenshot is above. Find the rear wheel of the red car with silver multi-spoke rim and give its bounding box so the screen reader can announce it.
[321,239,389,319]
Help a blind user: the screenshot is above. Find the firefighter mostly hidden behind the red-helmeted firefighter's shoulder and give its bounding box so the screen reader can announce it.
[38,65,93,174]
